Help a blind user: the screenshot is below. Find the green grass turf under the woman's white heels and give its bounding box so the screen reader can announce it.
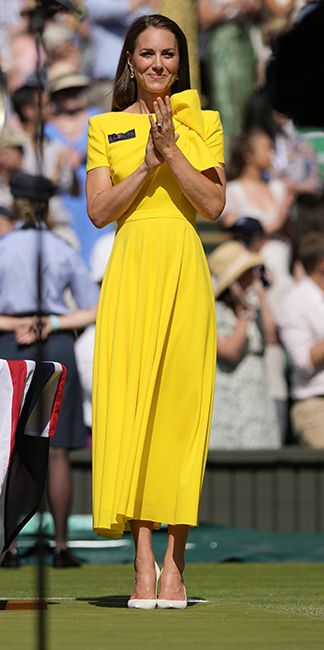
[0,563,324,650]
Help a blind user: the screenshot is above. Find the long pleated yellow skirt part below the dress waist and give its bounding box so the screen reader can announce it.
[93,215,216,537]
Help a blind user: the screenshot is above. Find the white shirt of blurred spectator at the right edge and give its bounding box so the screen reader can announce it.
[279,277,324,399]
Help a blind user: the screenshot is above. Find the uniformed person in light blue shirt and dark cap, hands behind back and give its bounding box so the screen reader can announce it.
[0,172,99,567]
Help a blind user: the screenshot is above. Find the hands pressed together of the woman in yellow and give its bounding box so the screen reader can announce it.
[145,97,179,170]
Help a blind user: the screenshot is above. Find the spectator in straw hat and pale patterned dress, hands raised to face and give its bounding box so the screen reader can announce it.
[208,242,281,449]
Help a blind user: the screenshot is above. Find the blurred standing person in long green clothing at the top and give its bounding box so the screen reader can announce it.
[198,0,261,159]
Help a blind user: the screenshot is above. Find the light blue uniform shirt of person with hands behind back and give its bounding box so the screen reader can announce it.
[0,227,99,316]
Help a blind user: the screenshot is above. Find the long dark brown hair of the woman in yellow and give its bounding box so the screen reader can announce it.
[112,14,190,111]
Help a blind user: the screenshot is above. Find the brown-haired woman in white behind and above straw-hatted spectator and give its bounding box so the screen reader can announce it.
[221,130,294,440]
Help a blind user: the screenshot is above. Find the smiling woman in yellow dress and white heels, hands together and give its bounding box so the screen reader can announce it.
[87,15,225,609]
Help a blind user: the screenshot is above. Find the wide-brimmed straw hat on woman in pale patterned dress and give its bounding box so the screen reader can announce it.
[207,241,264,298]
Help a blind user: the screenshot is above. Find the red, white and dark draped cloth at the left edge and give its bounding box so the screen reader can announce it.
[0,359,66,561]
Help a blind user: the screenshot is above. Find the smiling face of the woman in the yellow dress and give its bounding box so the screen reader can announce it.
[128,27,180,96]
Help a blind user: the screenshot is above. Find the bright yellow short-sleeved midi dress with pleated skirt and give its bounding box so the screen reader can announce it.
[87,90,223,537]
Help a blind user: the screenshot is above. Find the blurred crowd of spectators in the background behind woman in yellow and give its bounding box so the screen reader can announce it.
[0,0,324,450]
